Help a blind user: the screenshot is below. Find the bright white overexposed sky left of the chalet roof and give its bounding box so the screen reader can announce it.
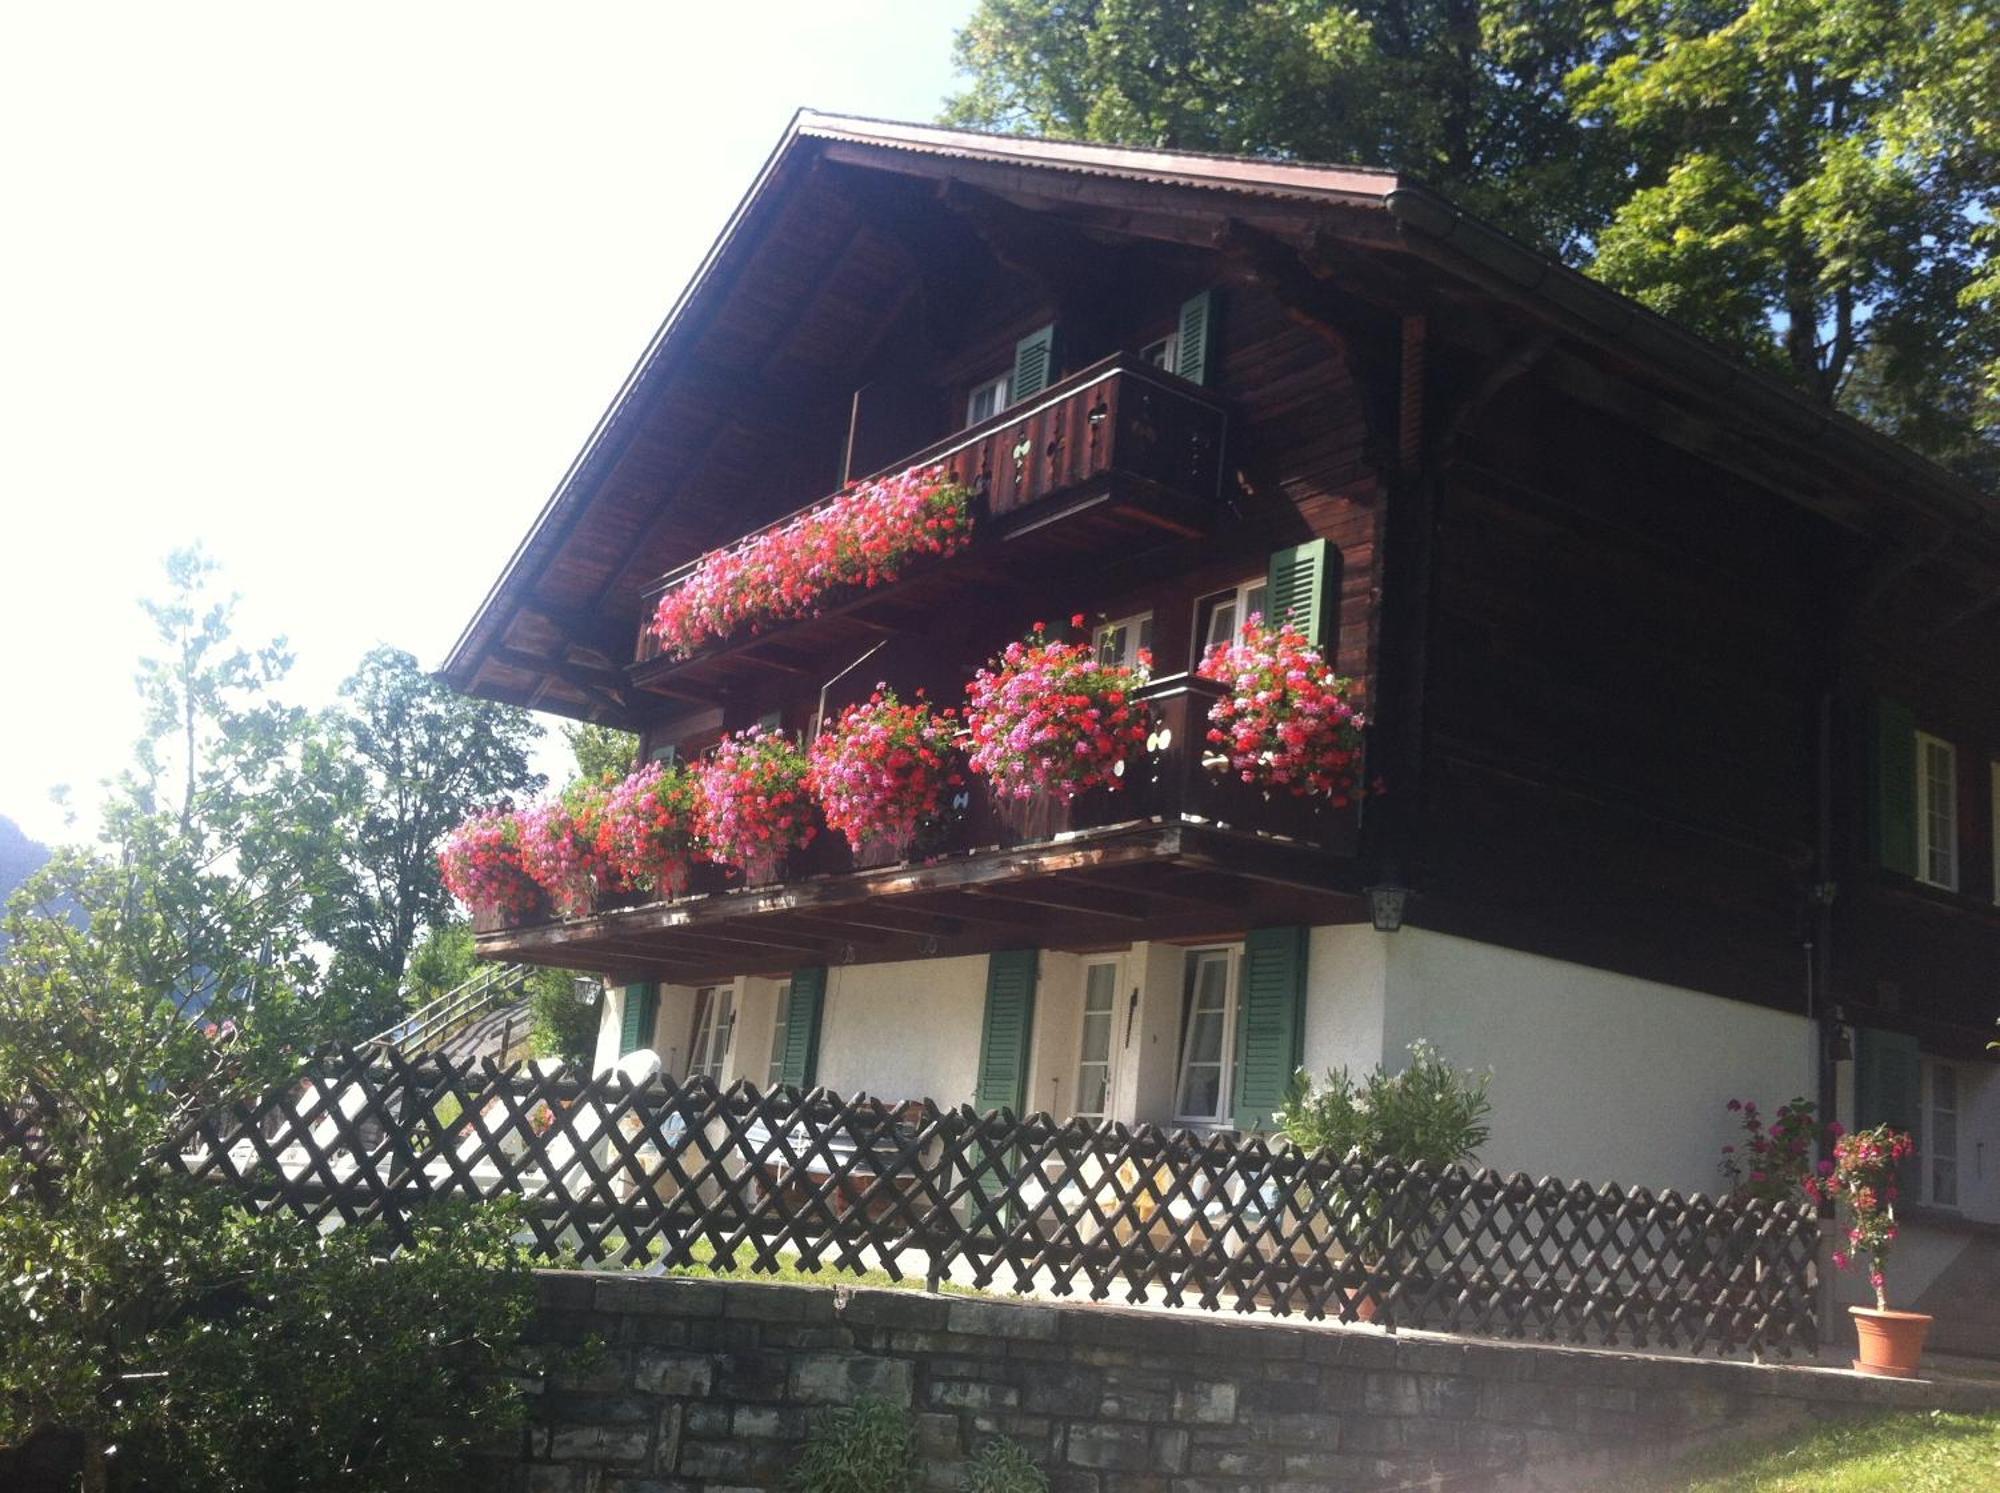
[0,0,970,841]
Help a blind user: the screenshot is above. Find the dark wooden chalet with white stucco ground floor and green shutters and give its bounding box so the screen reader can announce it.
[444,112,2000,1333]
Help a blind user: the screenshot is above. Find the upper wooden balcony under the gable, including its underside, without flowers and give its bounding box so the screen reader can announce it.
[630,356,1228,698]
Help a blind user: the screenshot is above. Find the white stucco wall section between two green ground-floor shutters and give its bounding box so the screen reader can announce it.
[820,955,986,1105]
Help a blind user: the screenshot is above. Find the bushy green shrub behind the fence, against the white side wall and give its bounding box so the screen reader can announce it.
[1278,1041,1492,1167]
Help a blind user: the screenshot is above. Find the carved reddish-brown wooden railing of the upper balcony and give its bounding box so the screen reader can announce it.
[634,356,1226,664]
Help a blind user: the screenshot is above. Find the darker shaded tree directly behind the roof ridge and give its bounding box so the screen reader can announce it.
[946,0,1618,252]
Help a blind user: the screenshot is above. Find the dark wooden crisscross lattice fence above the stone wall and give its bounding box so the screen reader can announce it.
[121,1055,1818,1353]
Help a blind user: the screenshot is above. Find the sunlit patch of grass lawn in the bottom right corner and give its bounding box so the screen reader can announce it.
[1644,1411,2000,1493]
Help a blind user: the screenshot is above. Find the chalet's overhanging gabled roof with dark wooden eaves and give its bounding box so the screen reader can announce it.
[442,110,2000,718]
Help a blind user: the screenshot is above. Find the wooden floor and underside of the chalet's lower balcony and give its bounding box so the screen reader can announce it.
[478,819,1368,985]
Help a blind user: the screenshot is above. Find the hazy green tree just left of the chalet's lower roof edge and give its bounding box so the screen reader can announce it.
[314,648,542,1021]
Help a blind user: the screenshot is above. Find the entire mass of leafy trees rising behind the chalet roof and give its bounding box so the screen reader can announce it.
[946,0,2000,480]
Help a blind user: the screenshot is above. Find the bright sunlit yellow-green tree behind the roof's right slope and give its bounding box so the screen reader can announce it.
[1572,0,2000,450]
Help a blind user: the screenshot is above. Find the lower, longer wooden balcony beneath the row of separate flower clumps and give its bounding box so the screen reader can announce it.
[478,674,1364,983]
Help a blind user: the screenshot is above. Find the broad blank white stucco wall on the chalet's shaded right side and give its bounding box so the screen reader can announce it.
[1384,929,1814,1193]
